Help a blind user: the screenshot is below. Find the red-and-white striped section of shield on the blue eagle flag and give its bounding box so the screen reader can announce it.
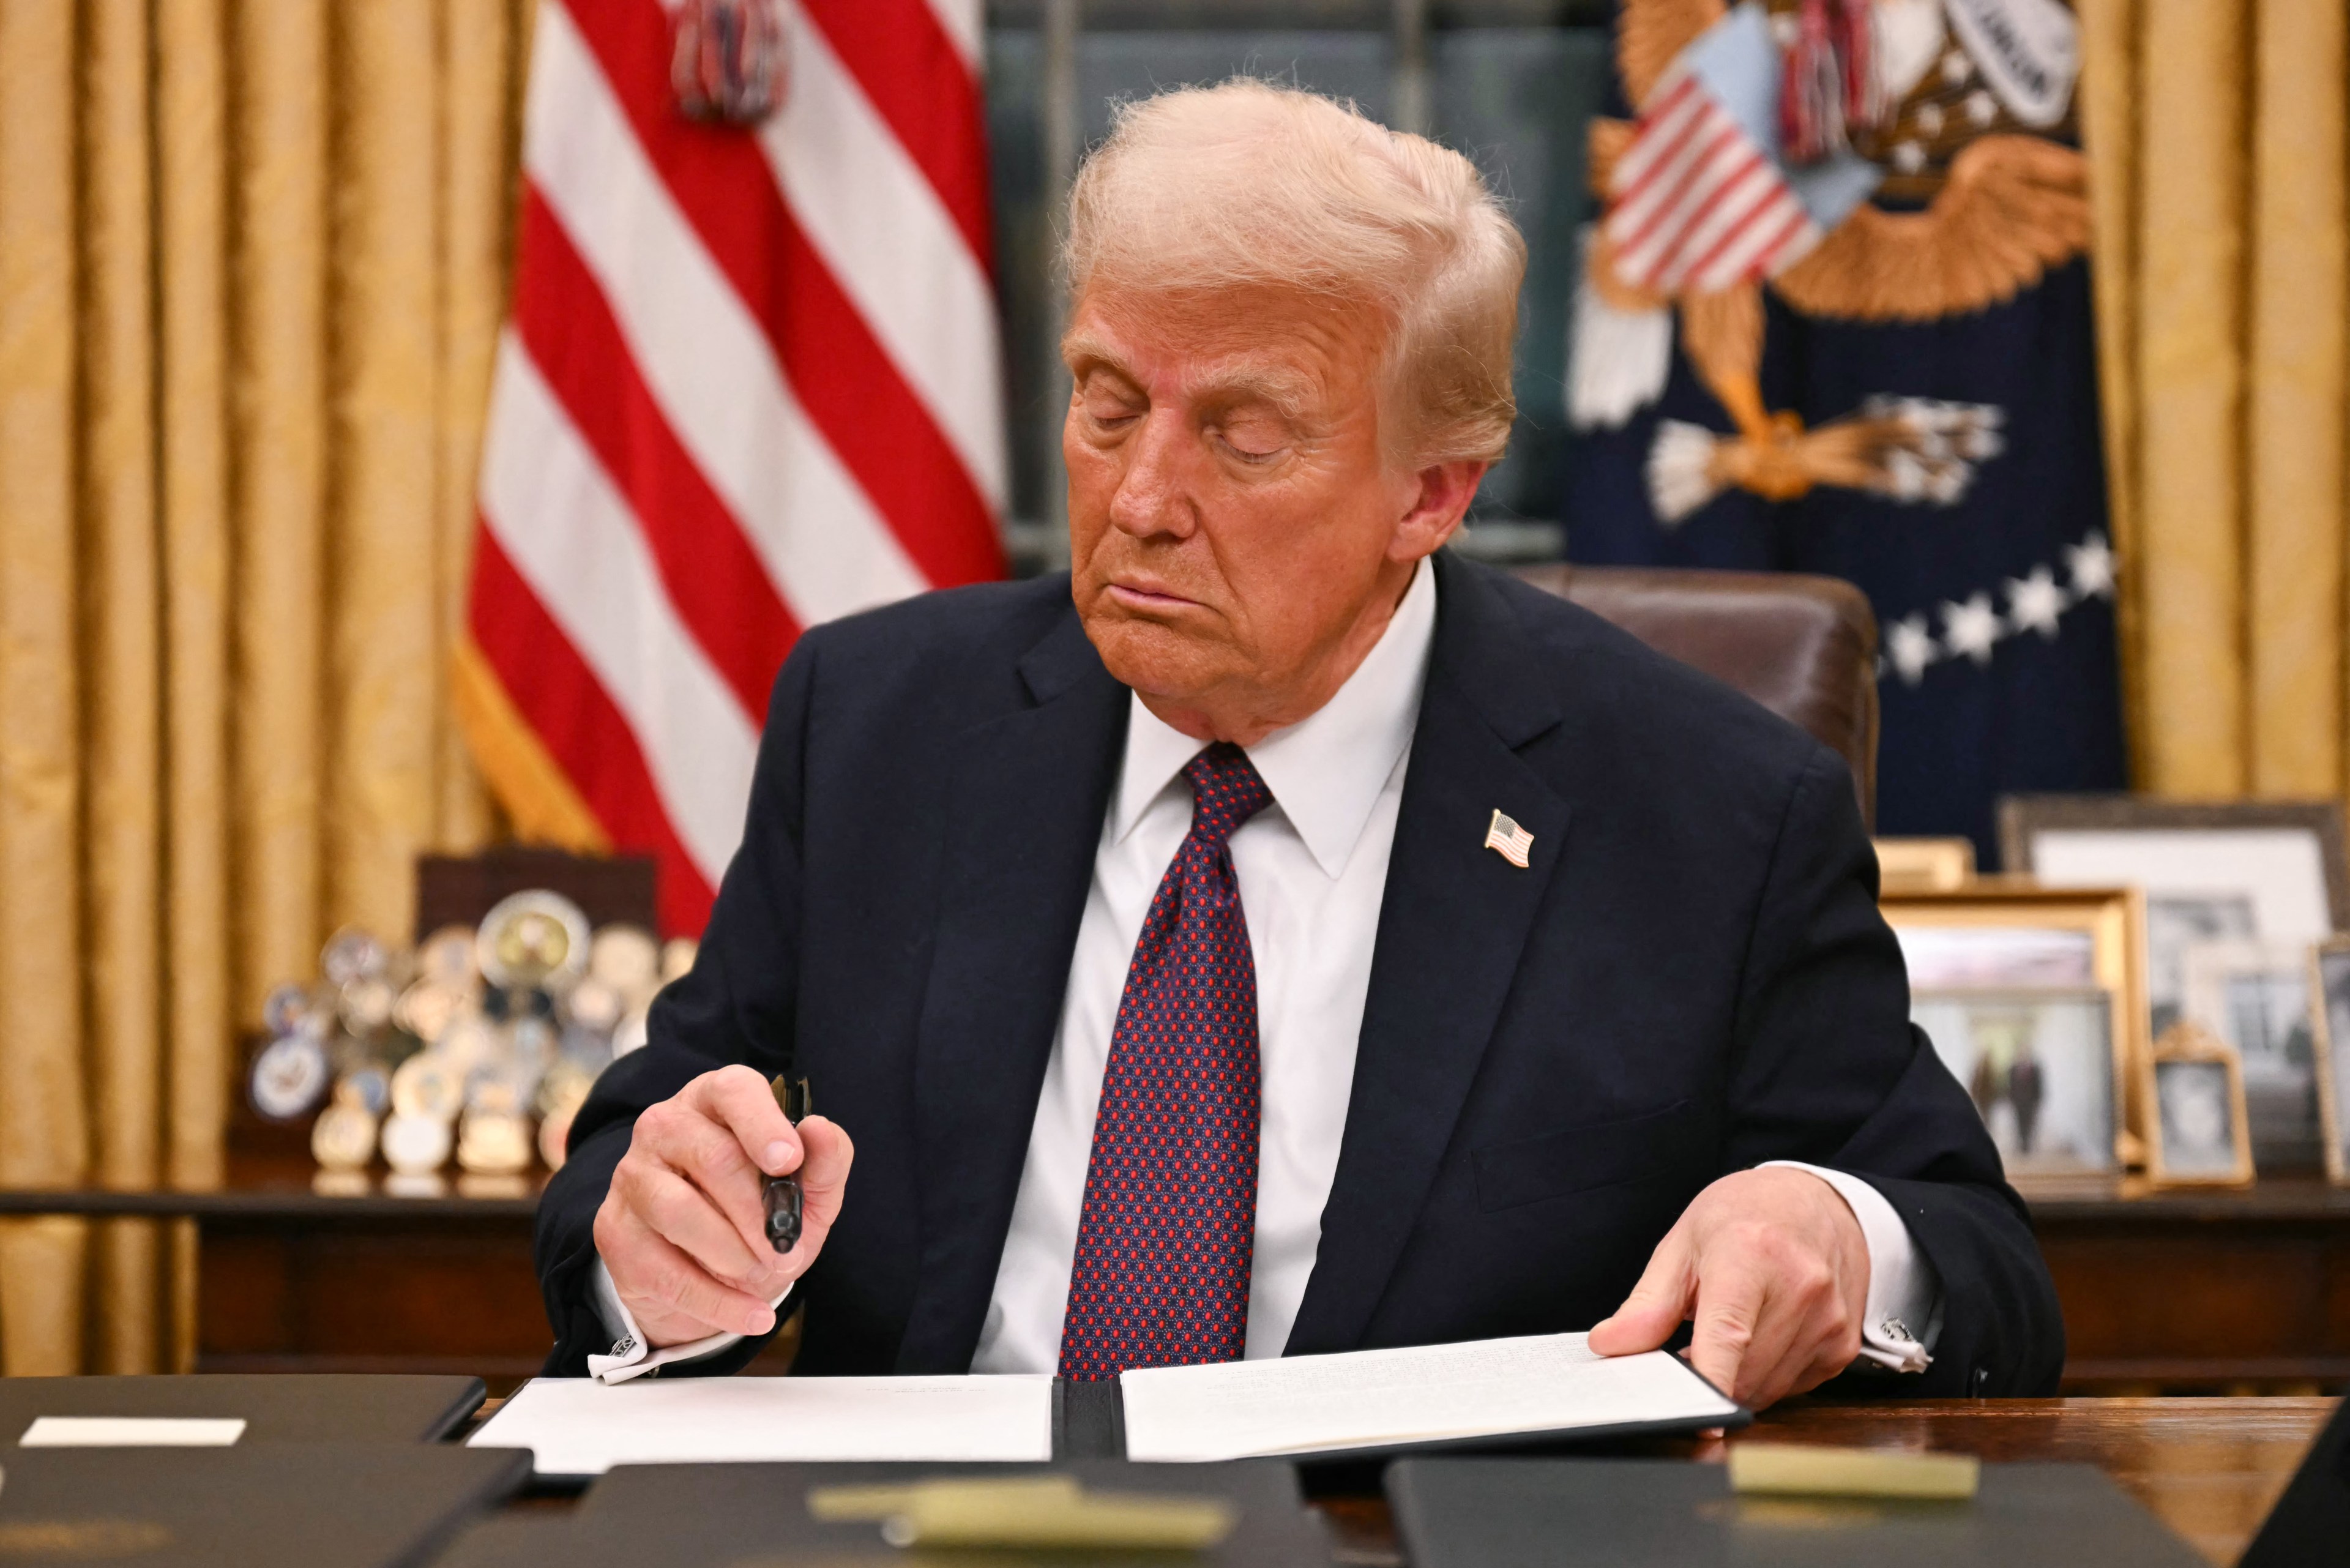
[1608,73,1821,294]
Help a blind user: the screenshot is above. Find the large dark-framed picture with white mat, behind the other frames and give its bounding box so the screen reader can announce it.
[2000,794,2350,1034]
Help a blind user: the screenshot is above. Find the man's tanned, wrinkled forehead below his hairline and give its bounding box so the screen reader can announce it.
[1062,282,1387,411]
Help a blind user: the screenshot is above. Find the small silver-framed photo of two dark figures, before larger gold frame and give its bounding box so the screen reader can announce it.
[1911,990,2122,1180]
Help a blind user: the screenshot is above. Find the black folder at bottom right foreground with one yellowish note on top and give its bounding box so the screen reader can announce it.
[1387,1460,2202,1568]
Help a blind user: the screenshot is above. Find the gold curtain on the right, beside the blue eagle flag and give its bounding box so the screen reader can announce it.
[2080,0,2350,799]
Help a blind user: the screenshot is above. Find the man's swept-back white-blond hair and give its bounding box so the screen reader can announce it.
[1062,78,1525,466]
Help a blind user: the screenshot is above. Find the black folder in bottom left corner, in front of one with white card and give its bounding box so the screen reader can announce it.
[0,1443,531,1568]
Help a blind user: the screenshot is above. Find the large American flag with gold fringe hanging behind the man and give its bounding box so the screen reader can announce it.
[456,0,1006,933]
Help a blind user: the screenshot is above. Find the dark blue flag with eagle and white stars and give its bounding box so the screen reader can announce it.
[1563,0,2127,867]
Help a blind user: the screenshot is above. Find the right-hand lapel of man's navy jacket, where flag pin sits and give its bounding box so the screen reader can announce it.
[1288,554,1567,1354]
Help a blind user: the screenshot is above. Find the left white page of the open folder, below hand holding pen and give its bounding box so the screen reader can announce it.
[468,1378,1053,1476]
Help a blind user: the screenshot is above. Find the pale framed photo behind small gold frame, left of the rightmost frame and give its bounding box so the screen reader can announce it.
[2181,940,2324,1171]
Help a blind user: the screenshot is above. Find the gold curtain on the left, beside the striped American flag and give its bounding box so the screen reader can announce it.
[0,0,526,1373]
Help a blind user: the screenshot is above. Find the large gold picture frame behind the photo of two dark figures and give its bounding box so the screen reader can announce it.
[1880,879,2152,1168]
